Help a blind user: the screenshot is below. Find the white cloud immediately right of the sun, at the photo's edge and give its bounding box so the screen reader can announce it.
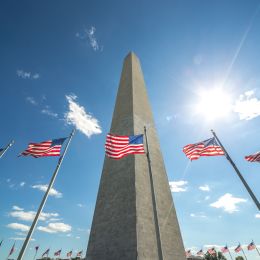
[233,90,260,120]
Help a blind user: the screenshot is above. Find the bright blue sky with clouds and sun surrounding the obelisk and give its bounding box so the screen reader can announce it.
[0,0,260,260]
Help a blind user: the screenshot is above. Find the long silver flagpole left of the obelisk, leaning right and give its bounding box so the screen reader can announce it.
[17,129,75,260]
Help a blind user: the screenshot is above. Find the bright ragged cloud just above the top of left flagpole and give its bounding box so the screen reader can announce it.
[65,95,102,137]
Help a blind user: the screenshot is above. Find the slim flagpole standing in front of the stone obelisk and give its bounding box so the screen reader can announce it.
[144,126,163,260]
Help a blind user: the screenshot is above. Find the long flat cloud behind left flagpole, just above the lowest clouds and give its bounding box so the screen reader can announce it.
[9,206,59,221]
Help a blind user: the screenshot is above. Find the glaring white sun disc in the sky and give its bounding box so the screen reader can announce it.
[195,88,232,121]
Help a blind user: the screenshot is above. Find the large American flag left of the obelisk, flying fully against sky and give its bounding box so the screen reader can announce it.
[20,138,67,158]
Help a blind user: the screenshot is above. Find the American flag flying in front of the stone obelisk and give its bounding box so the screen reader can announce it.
[105,134,144,159]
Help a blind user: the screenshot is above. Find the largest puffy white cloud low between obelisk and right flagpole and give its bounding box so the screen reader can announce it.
[210,193,247,214]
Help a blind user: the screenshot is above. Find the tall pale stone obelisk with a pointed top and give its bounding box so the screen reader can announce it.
[86,52,186,260]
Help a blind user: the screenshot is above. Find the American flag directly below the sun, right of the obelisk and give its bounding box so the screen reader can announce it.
[183,137,225,161]
